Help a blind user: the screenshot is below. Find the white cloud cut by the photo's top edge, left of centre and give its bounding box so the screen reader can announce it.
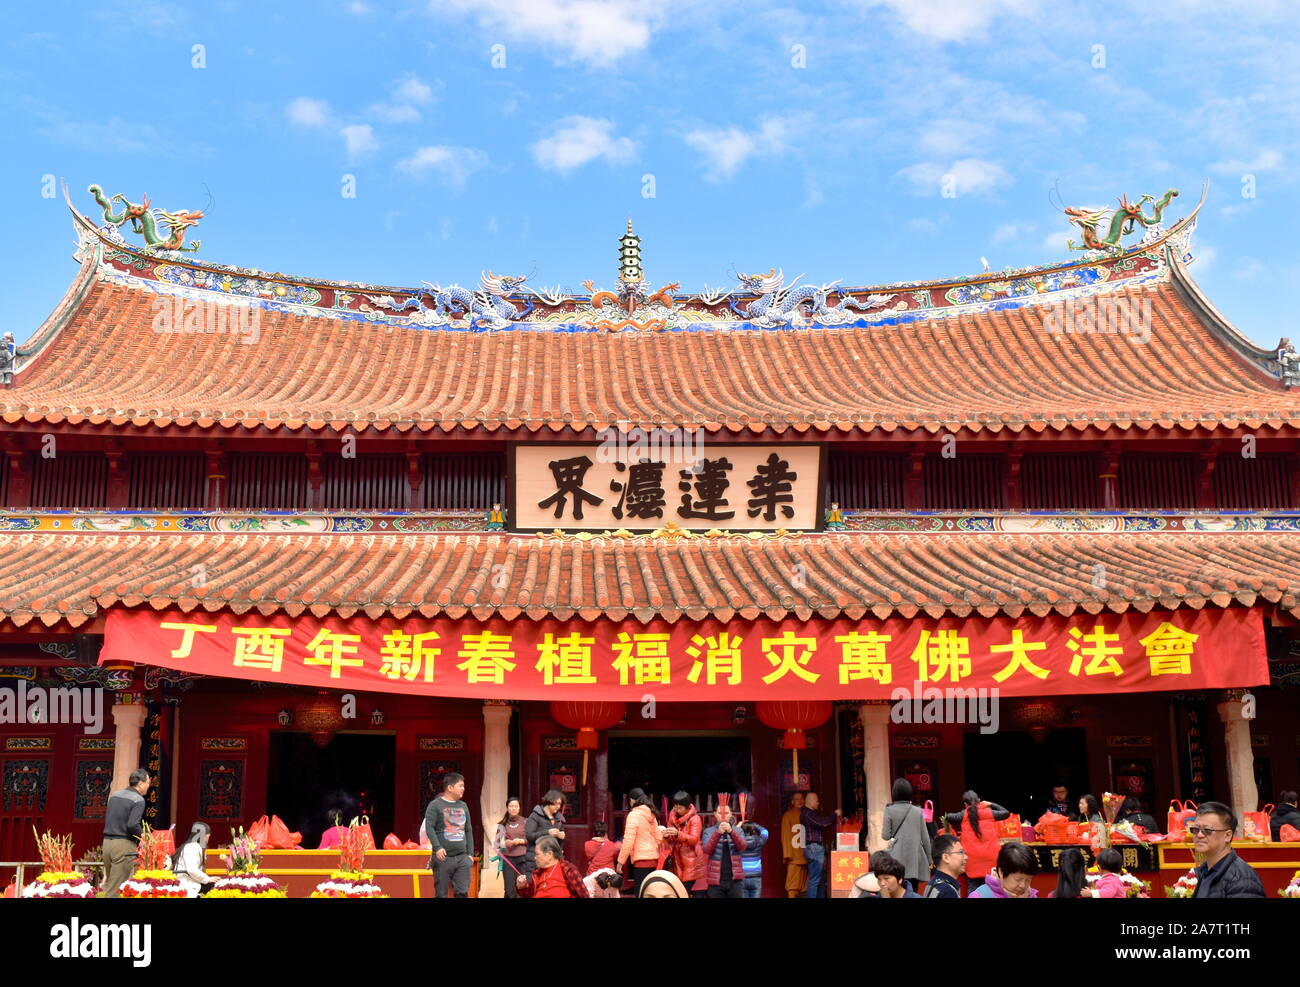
[429,0,668,66]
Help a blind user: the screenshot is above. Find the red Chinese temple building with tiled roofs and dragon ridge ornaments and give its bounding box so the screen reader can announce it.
[0,186,1300,896]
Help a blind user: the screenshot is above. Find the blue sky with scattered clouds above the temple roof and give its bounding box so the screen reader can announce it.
[0,0,1300,346]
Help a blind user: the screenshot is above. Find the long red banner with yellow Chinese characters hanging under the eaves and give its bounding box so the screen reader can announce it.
[100,609,1269,701]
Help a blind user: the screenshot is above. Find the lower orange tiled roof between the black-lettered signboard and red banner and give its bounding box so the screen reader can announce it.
[0,532,1300,627]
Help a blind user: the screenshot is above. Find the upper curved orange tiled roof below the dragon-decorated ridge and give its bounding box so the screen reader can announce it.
[0,280,1300,434]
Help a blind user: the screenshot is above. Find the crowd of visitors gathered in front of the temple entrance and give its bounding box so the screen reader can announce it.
[103,770,1300,899]
